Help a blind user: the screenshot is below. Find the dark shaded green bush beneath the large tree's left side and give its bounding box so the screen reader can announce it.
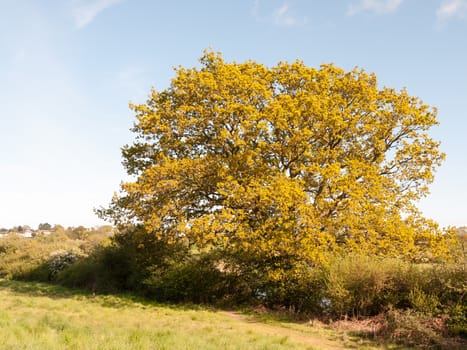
[55,226,201,299]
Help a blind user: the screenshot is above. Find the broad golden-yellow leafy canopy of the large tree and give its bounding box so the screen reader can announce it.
[100,51,454,262]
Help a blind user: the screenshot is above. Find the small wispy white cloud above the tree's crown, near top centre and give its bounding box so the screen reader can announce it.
[251,0,307,27]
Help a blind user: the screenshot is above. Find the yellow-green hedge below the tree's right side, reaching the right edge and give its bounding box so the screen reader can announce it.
[322,255,467,317]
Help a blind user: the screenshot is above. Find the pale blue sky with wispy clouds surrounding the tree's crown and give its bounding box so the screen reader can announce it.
[0,0,467,227]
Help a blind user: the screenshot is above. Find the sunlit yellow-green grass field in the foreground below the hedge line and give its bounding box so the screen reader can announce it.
[0,280,406,350]
